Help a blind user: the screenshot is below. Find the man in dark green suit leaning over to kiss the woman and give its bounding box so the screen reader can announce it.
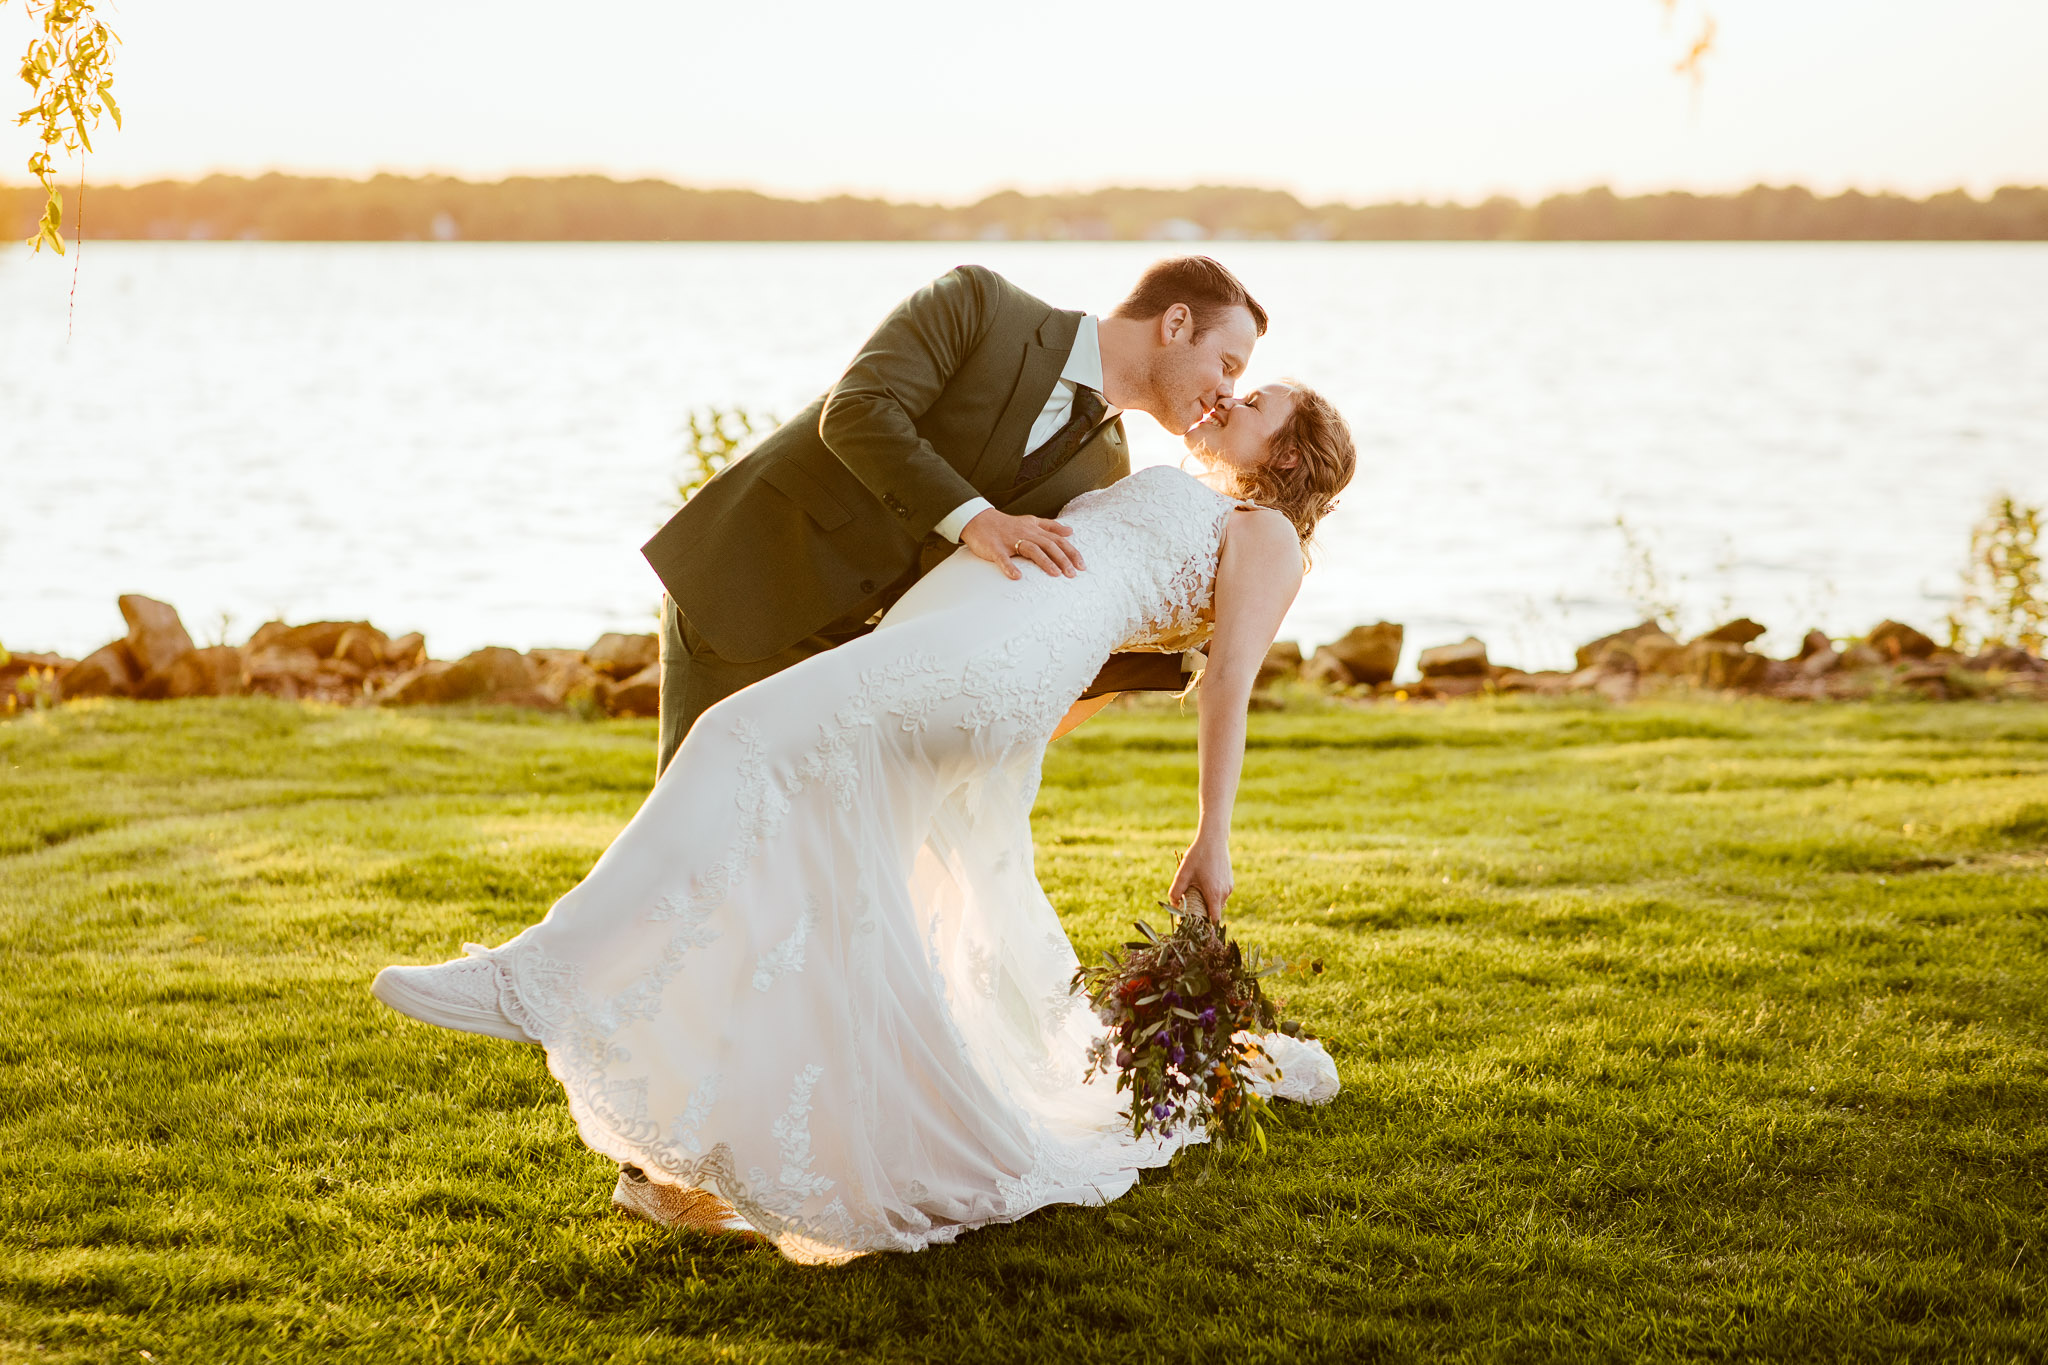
[641,256,1266,772]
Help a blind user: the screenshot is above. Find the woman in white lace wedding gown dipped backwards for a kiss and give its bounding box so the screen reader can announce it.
[373,385,1356,1263]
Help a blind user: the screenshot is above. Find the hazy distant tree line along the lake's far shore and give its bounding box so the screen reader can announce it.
[0,172,2048,241]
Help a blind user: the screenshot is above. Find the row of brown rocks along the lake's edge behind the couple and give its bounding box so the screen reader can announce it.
[0,593,2048,716]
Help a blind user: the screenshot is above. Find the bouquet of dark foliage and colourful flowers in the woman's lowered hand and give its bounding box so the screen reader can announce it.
[1073,892,1323,1150]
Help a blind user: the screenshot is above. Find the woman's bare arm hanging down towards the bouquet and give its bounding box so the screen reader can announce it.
[1167,510,1303,919]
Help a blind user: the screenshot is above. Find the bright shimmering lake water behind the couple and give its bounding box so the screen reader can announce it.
[0,241,2048,667]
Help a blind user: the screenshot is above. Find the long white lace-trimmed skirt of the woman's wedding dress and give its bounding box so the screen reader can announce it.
[489,527,1327,1261]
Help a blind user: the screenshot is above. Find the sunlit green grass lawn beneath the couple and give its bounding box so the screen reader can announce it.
[0,700,2048,1365]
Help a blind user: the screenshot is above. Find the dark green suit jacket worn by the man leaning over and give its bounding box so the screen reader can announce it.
[641,266,1130,663]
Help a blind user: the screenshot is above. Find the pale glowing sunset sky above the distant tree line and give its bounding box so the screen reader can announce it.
[16,0,2048,203]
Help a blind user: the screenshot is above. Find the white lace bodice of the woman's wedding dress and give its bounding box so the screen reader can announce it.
[1061,465,1251,651]
